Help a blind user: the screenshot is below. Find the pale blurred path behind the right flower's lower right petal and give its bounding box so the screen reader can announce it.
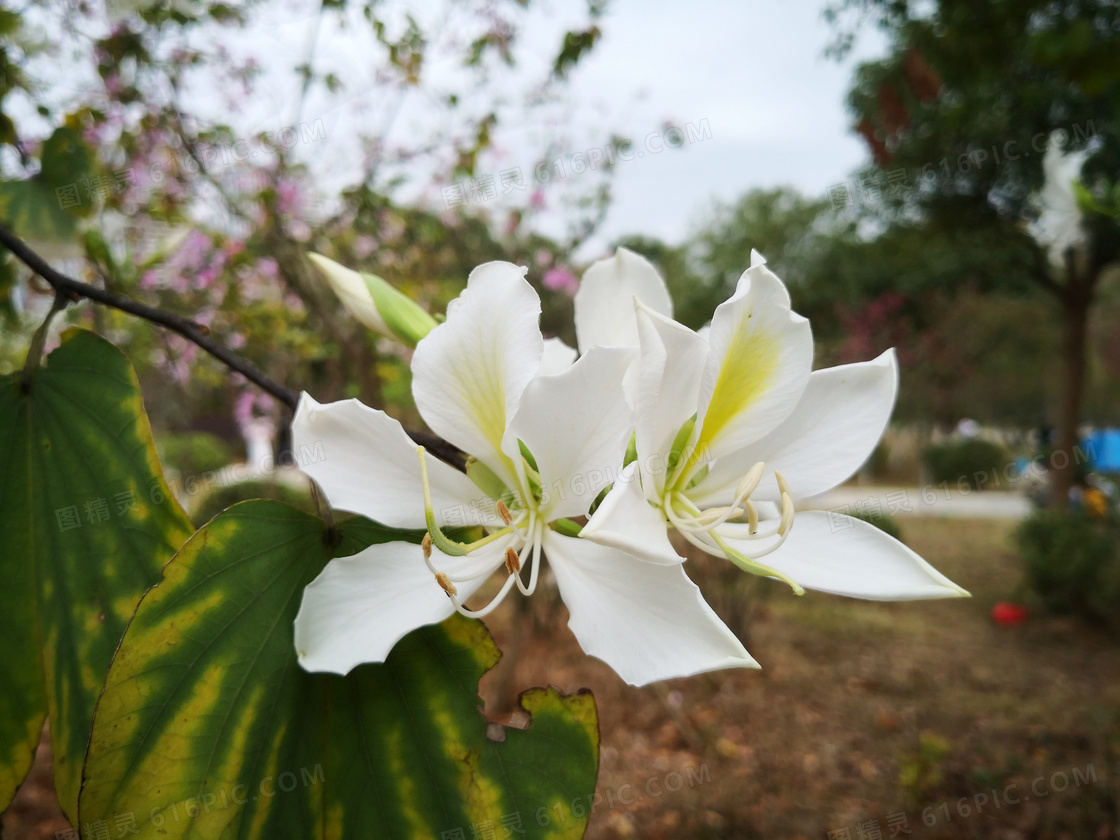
[799,485,1032,520]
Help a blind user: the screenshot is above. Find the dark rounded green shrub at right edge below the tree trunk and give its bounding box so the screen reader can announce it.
[1015,511,1120,622]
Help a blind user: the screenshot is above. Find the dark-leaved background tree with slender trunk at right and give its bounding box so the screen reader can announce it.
[830,0,1120,506]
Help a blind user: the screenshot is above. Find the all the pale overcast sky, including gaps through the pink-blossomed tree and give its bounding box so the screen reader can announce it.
[206,0,884,259]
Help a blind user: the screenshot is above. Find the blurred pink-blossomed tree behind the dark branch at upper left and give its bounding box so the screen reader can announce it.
[0,0,609,468]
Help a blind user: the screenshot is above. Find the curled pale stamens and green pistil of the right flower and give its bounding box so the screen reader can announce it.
[662,461,804,595]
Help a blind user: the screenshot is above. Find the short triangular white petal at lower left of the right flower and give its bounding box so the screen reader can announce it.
[579,463,684,566]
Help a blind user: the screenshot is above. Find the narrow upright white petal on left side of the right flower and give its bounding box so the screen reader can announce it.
[629,305,708,495]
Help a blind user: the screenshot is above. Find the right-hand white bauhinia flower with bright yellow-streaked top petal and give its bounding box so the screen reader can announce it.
[580,253,968,599]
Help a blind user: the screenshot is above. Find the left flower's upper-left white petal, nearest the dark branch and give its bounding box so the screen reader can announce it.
[291,393,502,528]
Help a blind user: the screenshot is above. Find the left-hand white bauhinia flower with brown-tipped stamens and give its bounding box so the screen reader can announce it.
[292,262,757,684]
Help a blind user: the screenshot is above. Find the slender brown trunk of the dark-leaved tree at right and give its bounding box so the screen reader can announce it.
[1048,277,1093,511]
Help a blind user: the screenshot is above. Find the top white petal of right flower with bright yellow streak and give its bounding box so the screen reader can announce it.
[697,264,813,458]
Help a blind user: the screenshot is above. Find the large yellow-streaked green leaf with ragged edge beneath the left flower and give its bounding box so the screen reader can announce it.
[81,501,599,840]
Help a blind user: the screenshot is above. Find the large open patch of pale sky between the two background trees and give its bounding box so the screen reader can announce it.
[548,0,883,256]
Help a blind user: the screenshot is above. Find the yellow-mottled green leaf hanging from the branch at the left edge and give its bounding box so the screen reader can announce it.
[0,329,192,819]
